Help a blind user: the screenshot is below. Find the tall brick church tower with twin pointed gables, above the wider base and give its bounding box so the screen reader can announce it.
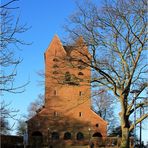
[45,35,91,111]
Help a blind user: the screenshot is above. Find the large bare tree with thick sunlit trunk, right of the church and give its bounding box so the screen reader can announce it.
[65,0,148,148]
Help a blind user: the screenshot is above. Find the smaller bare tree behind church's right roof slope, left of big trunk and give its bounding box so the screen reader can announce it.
[92,89,117,133]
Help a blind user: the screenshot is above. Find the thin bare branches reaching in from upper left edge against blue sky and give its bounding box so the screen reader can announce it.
[0,0,28,93]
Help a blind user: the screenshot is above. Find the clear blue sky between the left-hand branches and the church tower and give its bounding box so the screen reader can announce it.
[1,0,147,145]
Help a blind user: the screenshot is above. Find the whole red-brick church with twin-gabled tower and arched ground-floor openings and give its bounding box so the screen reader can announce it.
[27,35,107,148]
